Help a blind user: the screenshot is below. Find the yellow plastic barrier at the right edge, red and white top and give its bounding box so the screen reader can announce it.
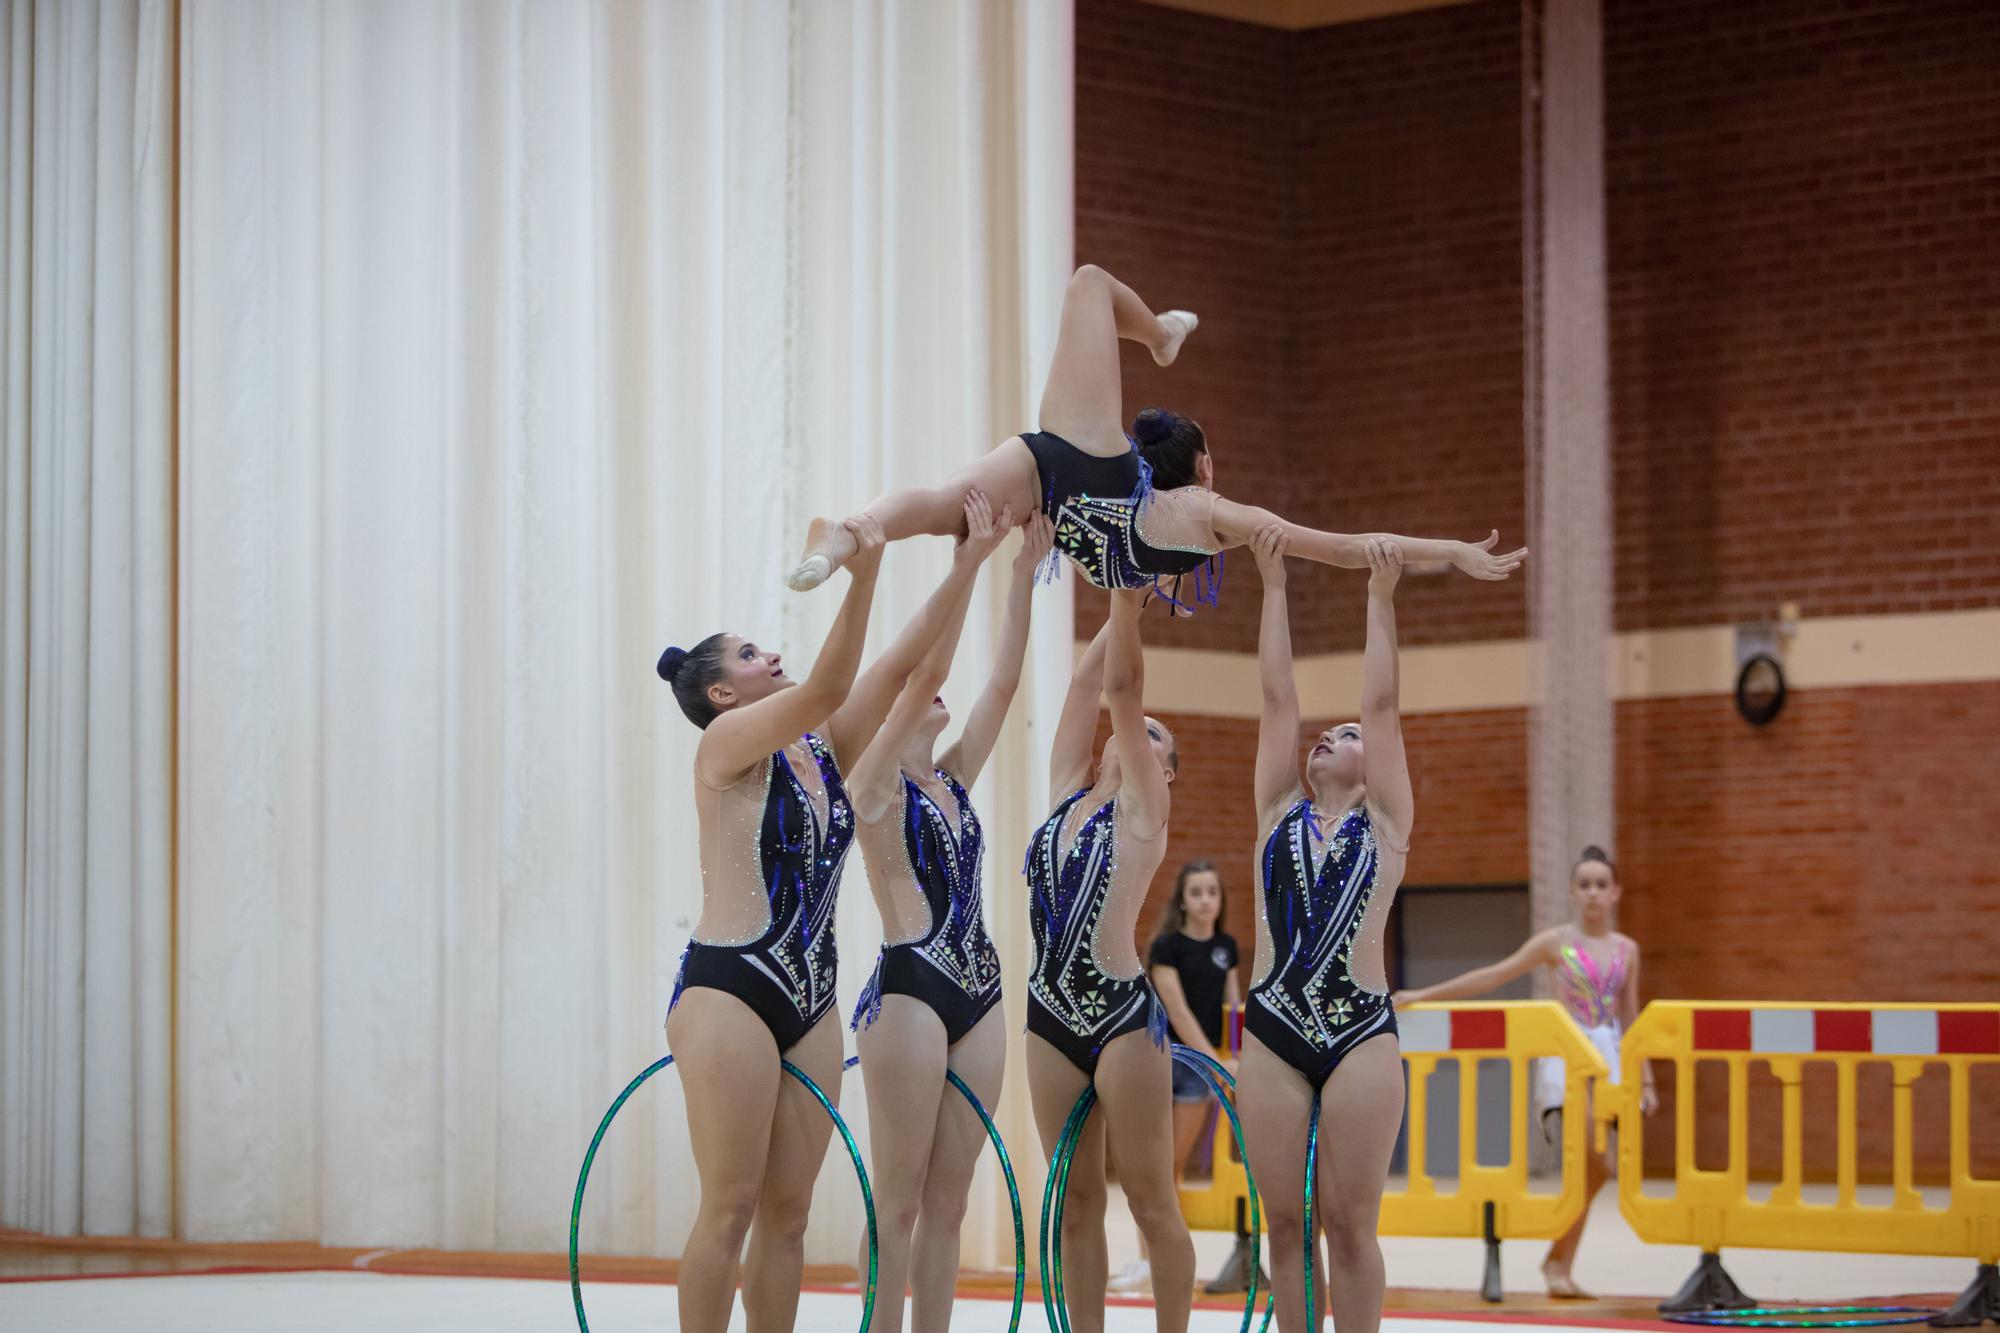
[1596,1001,2000,1309]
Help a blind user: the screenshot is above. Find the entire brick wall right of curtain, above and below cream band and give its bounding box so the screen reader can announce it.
[1076,0,2000,1171]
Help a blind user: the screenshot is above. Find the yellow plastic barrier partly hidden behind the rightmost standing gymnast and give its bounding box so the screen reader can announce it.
[1180,1001,1610,1239]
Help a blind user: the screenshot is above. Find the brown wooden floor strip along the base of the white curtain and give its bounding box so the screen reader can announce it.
[0,1231,1688,1323]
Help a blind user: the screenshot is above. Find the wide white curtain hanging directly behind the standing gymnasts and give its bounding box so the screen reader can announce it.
[180,0,1070,1261]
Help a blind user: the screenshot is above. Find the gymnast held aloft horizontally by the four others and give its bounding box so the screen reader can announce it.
[788,264,1526,600]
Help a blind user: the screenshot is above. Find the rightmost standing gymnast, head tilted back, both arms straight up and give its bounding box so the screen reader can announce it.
[1236,526,1414,1333]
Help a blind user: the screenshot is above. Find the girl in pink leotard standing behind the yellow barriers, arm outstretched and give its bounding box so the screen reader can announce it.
[1396,847,1656,1299]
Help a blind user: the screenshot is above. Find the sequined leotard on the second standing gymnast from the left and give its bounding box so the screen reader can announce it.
[854,769,1000,1043]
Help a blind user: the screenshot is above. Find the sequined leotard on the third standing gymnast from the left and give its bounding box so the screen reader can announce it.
[1022,789,1166,1075]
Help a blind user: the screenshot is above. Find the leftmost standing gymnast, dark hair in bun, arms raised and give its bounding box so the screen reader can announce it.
[660,516,1032,1333]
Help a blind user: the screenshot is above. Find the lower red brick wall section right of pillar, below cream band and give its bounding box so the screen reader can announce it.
[1618,683,2000,1179]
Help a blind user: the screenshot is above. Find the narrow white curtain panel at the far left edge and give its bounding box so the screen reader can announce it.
[0,0,174,1235]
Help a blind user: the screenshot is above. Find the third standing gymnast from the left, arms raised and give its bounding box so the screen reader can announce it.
[1026,590,1194,1333]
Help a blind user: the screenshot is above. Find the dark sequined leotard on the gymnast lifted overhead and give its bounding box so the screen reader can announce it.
[1020,430,1222,604]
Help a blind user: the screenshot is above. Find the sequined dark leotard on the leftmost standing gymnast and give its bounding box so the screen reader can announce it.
[668,733,854,1051]
